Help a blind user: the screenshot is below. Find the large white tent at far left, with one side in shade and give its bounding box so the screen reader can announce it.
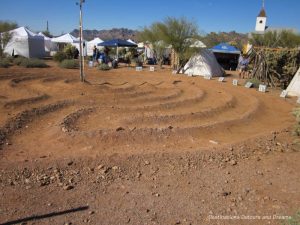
[4,27,45,58]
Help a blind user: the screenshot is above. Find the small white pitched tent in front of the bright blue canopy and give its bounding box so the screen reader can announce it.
[183,49,224,77]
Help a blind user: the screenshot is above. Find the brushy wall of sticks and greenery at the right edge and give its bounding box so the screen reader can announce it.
[250,48,300,89]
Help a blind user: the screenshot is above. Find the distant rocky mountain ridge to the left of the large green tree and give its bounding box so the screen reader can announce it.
[71,28,138,41]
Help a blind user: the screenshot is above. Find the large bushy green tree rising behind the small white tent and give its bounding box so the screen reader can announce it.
[139,17,199,72]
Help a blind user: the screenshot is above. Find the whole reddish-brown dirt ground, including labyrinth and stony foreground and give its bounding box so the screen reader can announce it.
[0,61,300,225]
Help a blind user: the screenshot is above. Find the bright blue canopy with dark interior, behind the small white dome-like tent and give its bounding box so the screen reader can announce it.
[211,43,241,70]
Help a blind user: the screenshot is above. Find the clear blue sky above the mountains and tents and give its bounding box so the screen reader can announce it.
[0,0,300,35]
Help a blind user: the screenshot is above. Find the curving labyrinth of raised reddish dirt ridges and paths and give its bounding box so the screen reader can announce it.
[0,68,293,160]
